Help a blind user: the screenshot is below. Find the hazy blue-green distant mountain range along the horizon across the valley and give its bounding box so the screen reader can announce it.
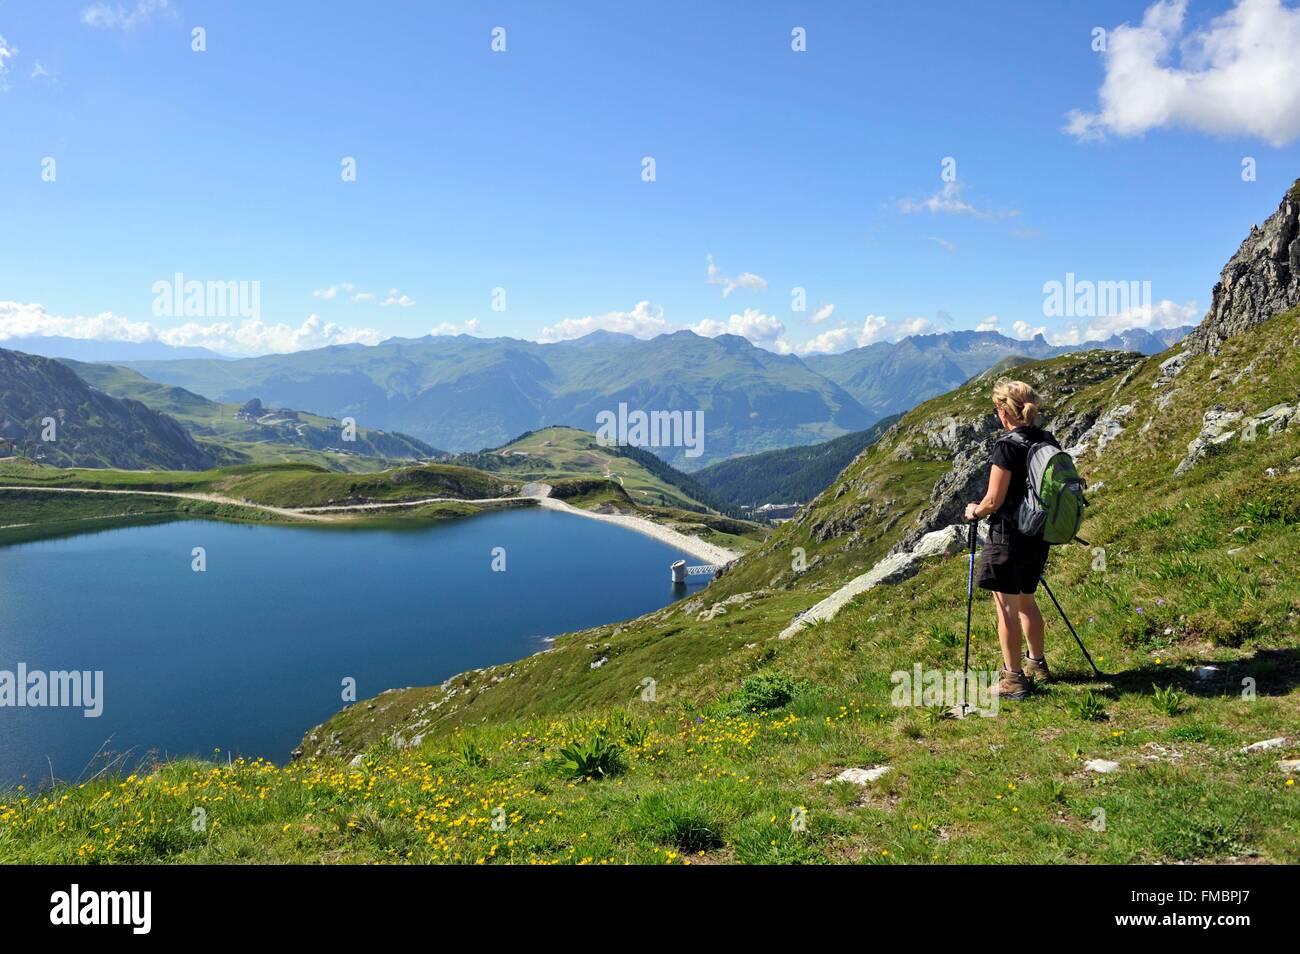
[65,329,1186,471]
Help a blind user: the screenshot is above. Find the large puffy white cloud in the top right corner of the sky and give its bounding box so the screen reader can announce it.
[1065,0,1300,147]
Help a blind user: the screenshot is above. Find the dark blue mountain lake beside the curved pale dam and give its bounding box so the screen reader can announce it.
[0,509,703,788]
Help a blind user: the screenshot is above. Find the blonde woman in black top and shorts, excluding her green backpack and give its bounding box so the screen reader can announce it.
[966,378,1057,699]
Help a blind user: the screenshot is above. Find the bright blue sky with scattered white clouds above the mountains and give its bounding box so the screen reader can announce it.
[0,0,1300,354]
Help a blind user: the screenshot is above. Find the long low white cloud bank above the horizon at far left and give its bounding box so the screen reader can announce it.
[0,302,382,355]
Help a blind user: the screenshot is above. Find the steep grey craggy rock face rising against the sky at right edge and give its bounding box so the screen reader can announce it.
[1186,179,1300,355]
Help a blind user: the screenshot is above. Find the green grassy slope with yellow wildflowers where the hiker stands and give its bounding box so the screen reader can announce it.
[0,313,1300,863]
